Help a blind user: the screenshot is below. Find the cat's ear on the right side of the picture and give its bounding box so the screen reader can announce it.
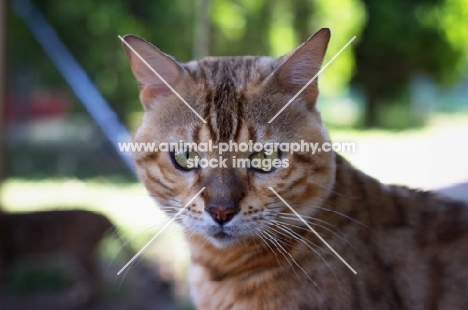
[273,28,330,103]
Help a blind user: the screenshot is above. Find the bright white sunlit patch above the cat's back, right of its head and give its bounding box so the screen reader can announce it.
[330,116,468,189]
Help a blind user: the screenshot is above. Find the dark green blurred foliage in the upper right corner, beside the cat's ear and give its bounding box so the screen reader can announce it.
[354,0,468,126]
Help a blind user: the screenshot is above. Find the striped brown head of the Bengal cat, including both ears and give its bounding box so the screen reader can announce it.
[124,29,335,246]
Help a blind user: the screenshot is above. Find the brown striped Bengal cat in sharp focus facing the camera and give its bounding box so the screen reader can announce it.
[124,29,468,310]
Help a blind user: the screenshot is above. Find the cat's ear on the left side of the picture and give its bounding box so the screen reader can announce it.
[122,35,184,109]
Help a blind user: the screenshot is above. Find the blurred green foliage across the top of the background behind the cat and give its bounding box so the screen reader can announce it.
[9,0,468,127]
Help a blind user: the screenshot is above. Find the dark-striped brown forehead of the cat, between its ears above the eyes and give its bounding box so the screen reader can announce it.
[143,56,314,142]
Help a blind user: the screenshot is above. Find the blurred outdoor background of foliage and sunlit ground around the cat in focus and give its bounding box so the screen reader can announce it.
[0,0,468,309]
